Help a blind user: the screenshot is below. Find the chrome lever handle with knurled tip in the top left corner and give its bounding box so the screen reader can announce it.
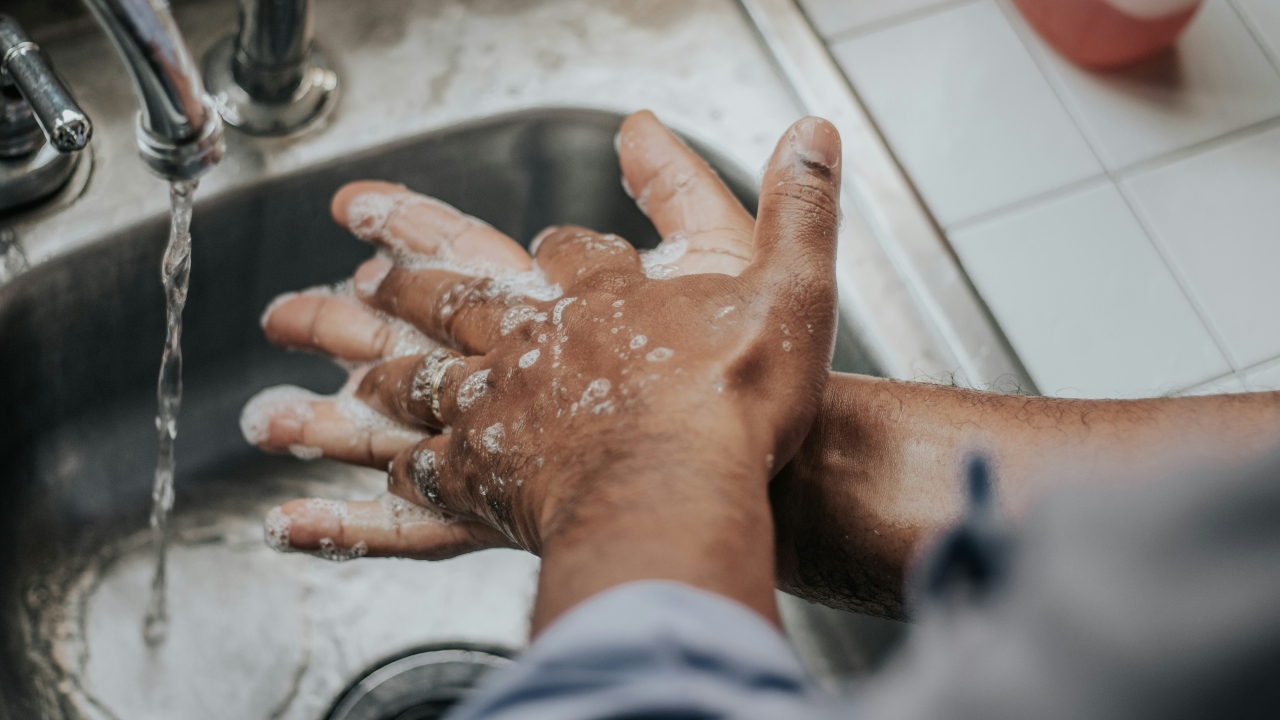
[0,14,93,152]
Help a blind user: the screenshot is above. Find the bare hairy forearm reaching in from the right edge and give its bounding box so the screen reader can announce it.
[771,374,1280,616]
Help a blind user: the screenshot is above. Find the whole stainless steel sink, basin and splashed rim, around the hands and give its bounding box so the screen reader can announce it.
[0,0,1029,720]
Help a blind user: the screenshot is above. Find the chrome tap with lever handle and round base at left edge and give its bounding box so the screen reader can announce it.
[0,14,93,213]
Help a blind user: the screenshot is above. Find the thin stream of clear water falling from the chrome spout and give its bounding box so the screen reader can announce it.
[142,181,197,646]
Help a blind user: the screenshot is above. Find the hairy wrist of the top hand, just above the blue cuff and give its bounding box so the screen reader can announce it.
[524,415,777,633]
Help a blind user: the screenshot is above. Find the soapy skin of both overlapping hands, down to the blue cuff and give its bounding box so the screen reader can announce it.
[254,110,840,633]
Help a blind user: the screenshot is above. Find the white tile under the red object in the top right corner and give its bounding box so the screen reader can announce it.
[1009,0,1280,170]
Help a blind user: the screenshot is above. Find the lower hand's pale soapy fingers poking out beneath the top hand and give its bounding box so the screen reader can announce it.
[244,111,808,559]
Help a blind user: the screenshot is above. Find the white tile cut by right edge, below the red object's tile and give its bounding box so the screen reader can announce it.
[1124,129,1280,368]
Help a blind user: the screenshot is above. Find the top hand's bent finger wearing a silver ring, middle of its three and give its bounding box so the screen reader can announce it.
[356,350,492,428]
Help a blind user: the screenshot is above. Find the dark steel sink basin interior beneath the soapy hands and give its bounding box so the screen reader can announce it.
[0,109,880,720]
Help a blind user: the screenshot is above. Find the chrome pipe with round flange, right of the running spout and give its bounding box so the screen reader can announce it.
[205,0,338,135]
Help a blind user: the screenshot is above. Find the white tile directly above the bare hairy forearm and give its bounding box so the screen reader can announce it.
[951,182,1231,397]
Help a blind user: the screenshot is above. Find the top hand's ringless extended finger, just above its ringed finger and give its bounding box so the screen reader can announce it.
[356,259,554,355]
